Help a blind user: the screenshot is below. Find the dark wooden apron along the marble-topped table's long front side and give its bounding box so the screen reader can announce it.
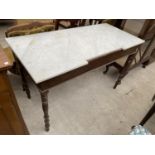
[36,46,139,91]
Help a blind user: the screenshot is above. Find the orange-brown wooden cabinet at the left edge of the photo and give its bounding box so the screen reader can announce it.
[0,46,28,135]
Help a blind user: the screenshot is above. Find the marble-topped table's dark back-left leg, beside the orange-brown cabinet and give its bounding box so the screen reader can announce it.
[20,65,31,99]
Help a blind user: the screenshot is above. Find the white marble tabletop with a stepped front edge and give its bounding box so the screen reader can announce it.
[6,24,144,83]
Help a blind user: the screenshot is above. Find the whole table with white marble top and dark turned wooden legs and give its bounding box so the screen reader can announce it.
[6,24,144,131]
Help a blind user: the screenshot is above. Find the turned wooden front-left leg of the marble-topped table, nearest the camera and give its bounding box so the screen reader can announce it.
[40,90,50,131]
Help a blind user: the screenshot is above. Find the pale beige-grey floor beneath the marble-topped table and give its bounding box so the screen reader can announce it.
[9,63,155,135]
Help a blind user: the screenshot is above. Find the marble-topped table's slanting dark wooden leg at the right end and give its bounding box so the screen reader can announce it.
[113,53,137,89]
